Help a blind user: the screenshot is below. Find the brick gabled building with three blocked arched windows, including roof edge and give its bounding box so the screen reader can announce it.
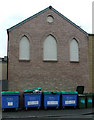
[7,6,90,95]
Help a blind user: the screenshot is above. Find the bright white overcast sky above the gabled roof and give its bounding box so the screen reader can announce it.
[0,0,94,57]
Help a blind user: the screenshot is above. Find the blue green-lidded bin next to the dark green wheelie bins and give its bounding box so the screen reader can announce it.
[61,91,78,108]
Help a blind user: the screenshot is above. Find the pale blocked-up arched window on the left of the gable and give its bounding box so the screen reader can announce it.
[19,36,30,60]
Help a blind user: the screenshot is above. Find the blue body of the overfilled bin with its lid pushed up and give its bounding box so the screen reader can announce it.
[24,93,42,110]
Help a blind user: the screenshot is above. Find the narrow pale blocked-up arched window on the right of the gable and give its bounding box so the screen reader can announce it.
[70,39,79,62]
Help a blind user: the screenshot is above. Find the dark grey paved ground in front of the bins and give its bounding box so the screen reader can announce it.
[2,108,94,120]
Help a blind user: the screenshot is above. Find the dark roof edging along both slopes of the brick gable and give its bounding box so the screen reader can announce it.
[7,6,88,35]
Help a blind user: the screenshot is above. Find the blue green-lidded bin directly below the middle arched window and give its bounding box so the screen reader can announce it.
[43,91,60,109]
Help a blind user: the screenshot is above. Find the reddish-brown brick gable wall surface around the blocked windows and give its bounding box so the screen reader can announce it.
[8,9,89,92]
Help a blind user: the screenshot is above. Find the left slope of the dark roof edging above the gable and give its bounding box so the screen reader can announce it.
[7,7,49,32]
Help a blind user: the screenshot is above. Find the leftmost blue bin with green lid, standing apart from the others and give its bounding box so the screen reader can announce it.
[1,91,19,110]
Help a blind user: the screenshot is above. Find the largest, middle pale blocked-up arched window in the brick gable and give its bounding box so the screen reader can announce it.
[43,35,57,61]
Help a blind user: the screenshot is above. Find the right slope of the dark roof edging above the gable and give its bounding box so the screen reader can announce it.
[52,7,88,36]
